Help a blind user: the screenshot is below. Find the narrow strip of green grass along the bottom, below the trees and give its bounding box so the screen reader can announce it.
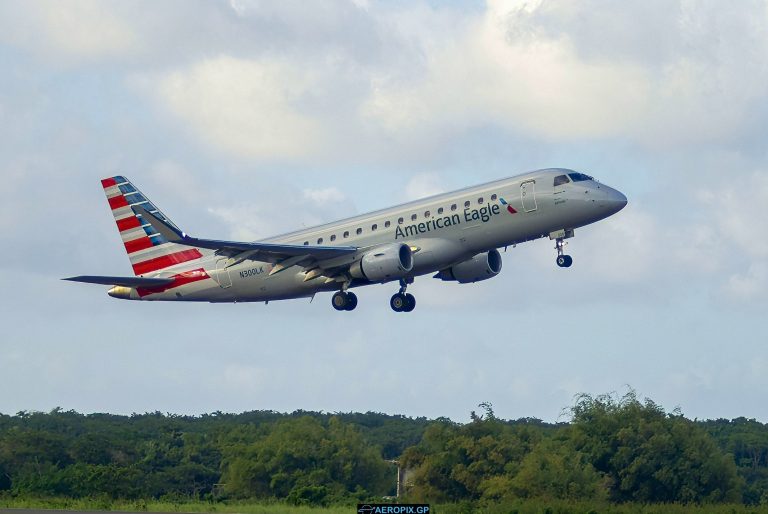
[0,496,768,514]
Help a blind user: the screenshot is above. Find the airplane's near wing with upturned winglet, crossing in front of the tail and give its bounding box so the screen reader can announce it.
[134,205,359,273]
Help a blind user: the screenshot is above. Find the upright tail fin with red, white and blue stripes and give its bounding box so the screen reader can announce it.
[101,176,210,276]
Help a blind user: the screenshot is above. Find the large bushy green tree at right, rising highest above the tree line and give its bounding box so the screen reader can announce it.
[571,391,741,502]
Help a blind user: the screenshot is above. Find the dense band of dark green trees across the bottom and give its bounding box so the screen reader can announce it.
[0,391,768,505]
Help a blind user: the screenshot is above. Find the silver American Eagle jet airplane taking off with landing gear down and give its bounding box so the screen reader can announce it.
[63,168,627,312]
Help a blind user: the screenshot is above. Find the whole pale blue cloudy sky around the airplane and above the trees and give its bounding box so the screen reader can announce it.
[0,0,768,421]
